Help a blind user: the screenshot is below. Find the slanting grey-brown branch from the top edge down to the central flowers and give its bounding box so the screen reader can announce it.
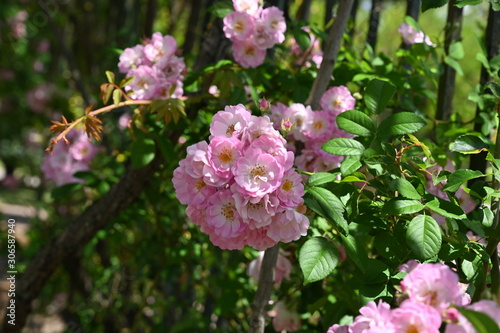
[305,0,354,110]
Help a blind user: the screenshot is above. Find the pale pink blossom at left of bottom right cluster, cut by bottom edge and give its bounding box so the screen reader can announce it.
[351,301,397,333]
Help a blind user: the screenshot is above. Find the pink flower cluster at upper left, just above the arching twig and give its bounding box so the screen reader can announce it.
[118,32,186,99]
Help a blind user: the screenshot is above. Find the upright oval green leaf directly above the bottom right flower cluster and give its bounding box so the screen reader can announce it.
[406,215,441,260]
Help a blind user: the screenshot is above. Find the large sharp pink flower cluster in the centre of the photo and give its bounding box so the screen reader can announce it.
[172,104,309,250]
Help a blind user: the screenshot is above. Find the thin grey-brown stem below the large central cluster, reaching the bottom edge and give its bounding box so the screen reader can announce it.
[248,244,280,333]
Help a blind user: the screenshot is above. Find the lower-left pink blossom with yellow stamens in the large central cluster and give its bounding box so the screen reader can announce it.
[207,190,247,238]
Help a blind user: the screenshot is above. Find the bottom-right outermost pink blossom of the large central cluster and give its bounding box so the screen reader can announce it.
[267,208,309,243]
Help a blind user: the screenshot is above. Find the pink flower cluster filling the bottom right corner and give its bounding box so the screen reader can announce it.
[328,261,500,333]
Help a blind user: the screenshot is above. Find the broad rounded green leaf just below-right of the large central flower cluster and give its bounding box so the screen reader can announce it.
[299,237,339,285]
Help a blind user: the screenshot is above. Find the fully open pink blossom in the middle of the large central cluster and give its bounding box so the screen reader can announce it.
[233,149,284,197]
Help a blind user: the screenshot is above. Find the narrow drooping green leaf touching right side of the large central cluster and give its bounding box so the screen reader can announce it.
[304,187,349,234]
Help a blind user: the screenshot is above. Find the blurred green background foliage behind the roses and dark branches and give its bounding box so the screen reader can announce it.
[0,0,494,332]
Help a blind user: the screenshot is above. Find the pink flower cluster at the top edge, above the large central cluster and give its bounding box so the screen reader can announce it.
[224,0,286,67]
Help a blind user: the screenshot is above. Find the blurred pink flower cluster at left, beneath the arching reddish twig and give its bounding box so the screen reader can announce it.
[42,130,99,186]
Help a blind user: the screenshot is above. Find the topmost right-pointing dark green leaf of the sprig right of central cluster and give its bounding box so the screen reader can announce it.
[377,112,427,137]
